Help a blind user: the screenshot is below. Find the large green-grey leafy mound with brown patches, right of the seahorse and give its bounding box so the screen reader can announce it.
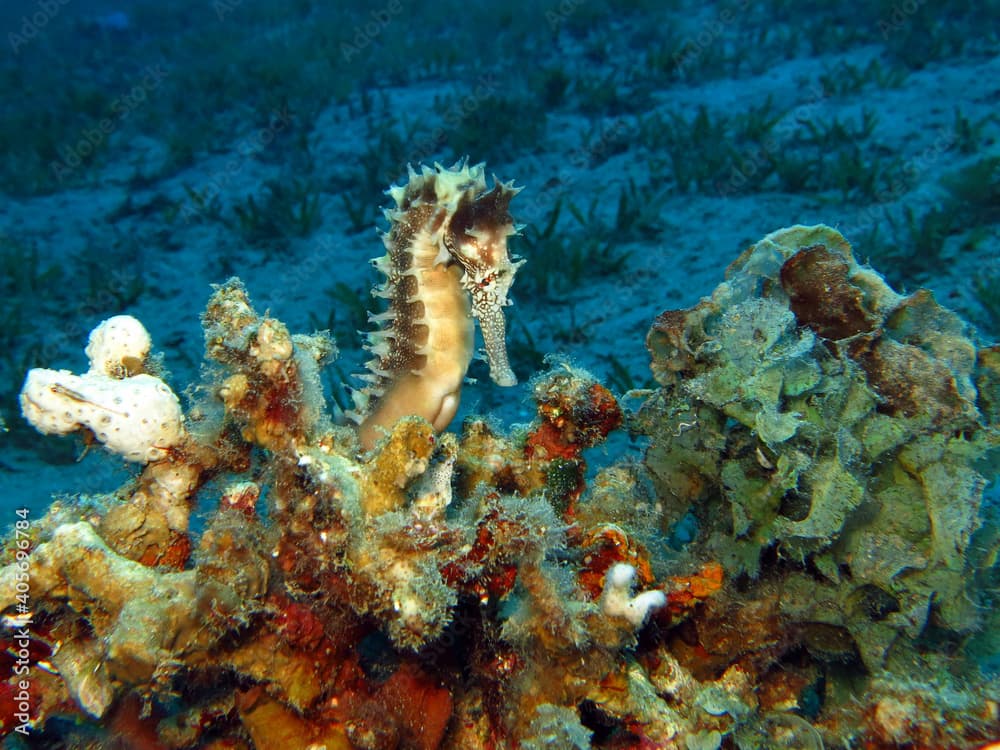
[640,226,1000,670]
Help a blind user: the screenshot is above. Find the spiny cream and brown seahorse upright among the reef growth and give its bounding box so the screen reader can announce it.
[350,160,525,450]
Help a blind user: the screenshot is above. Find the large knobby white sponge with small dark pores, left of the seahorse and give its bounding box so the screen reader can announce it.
[21,316,184,463]
